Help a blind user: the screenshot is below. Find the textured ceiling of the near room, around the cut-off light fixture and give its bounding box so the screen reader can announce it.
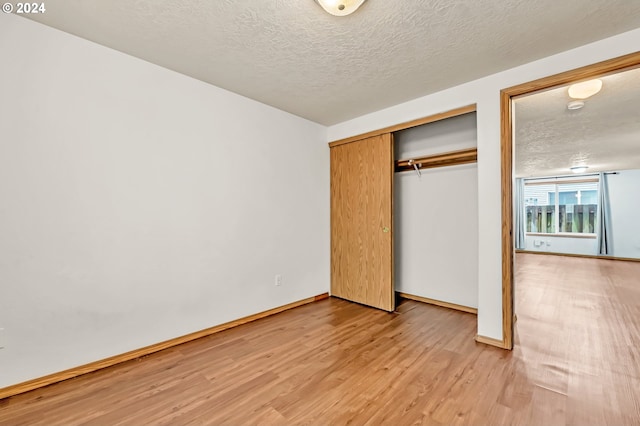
[17,0,640,125]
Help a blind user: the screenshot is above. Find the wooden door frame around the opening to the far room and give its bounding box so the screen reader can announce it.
[500,51,640,349]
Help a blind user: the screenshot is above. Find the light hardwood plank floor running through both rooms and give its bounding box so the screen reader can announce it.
[0,254,640,425]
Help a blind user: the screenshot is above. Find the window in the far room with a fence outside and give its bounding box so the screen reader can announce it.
[524,180,598,234]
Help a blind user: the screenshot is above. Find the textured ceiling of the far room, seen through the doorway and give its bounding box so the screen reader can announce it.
[514,69,640,177]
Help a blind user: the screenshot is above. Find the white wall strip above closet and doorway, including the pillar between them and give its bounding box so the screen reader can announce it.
[328,29,640,339]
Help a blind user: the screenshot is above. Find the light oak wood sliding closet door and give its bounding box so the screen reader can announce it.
[331,134,395,312]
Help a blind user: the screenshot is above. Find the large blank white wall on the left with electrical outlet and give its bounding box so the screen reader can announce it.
[0,14,329,387]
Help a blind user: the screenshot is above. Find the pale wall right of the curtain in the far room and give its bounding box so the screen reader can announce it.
[607,170,640,258]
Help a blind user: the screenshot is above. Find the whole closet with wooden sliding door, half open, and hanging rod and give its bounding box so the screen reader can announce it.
[329,105,478,312]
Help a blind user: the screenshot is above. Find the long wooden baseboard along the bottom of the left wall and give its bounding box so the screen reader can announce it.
[0,293,329,400]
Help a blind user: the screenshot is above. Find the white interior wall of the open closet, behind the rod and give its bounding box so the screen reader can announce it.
[394,113,478,308]
